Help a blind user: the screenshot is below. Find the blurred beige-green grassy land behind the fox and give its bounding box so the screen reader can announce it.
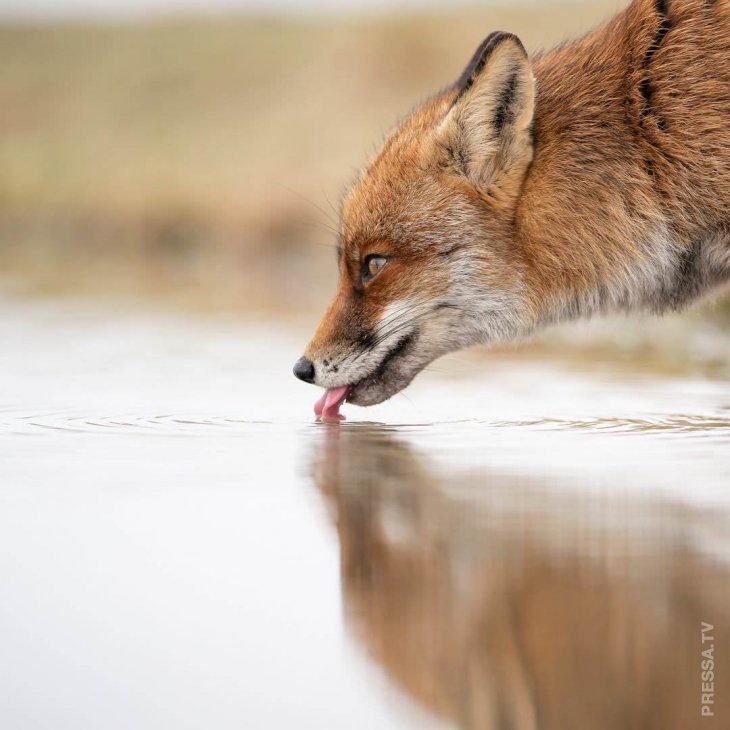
[0,0,728,370]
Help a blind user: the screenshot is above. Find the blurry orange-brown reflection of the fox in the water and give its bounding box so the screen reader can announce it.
[313,426,730,730]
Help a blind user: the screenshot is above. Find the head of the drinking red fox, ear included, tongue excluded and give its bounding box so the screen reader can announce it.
[294,33,535,406]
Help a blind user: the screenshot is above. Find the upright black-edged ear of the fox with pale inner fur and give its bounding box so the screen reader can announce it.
[436,32,535,190]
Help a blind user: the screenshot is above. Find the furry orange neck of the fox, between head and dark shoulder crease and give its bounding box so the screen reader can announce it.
[515,3,730,334]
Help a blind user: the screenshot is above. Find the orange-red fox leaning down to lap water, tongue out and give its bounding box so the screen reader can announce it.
[294,0,730,420]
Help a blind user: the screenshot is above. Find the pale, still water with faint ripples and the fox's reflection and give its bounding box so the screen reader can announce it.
[0,302,730,730]
